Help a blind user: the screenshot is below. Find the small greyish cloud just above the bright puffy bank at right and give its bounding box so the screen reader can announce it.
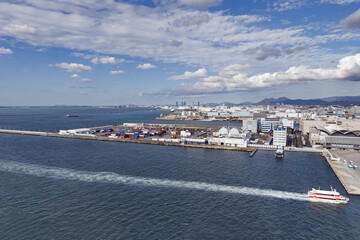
[246,45,307,60]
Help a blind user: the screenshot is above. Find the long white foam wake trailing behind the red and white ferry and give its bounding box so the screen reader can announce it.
[0,161,309,201]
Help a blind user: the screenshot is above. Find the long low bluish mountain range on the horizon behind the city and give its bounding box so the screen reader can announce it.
[255,96,360,106]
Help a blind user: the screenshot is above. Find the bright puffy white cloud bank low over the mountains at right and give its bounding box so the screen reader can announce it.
[144,54,360,96]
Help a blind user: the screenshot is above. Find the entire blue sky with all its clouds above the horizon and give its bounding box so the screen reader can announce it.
[0,0,360,106]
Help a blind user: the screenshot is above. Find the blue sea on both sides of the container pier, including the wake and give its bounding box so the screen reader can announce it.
[0,109,360,239]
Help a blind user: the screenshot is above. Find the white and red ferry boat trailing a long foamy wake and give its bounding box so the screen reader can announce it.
[308,187,349,204]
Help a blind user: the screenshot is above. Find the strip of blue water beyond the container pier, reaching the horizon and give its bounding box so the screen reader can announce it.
[0,108,242,132]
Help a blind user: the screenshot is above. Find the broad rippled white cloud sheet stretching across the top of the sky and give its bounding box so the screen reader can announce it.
[0,0,360,78]
